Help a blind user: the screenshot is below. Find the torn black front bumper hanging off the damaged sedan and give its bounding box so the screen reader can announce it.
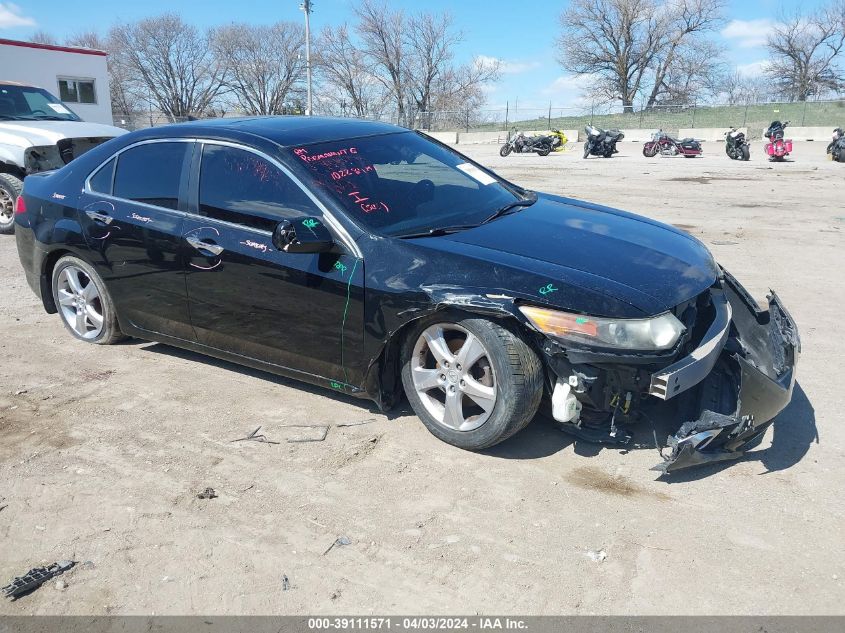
[652,273,801,473]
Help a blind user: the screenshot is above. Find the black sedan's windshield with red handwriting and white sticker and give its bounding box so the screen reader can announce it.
[291,132,520,236]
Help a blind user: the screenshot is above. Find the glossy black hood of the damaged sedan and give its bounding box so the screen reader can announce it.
[408,194,719,316]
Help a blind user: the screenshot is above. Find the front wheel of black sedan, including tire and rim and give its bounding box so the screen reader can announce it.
[402,314,543,451]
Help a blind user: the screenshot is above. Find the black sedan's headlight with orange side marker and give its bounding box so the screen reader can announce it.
[519,306,685,351]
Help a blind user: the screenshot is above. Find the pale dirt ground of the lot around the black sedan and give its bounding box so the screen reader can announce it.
[0,142,845,615]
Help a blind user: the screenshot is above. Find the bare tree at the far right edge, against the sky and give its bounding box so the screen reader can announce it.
[766,0,845,101]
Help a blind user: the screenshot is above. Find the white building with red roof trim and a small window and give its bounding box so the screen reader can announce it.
[0,39,112,125]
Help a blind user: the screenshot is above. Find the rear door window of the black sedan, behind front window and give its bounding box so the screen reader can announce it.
[112,143,186,209]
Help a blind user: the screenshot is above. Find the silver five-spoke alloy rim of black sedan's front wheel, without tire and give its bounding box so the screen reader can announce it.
[411,323,498,431]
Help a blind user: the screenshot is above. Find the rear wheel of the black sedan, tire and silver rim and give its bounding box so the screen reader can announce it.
[52,255,124,345]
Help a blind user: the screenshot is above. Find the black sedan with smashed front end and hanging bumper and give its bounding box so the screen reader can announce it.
[15,117,800,471]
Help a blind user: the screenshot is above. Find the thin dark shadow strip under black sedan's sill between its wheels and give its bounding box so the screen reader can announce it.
[138,341,411,420]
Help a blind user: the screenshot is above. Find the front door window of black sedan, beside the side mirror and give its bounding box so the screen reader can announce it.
[199,144,321,231]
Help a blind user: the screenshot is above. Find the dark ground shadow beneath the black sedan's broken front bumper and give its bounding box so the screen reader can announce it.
[483,383,819,483]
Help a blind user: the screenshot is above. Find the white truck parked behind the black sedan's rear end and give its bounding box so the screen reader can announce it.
[0,81,126,233]
